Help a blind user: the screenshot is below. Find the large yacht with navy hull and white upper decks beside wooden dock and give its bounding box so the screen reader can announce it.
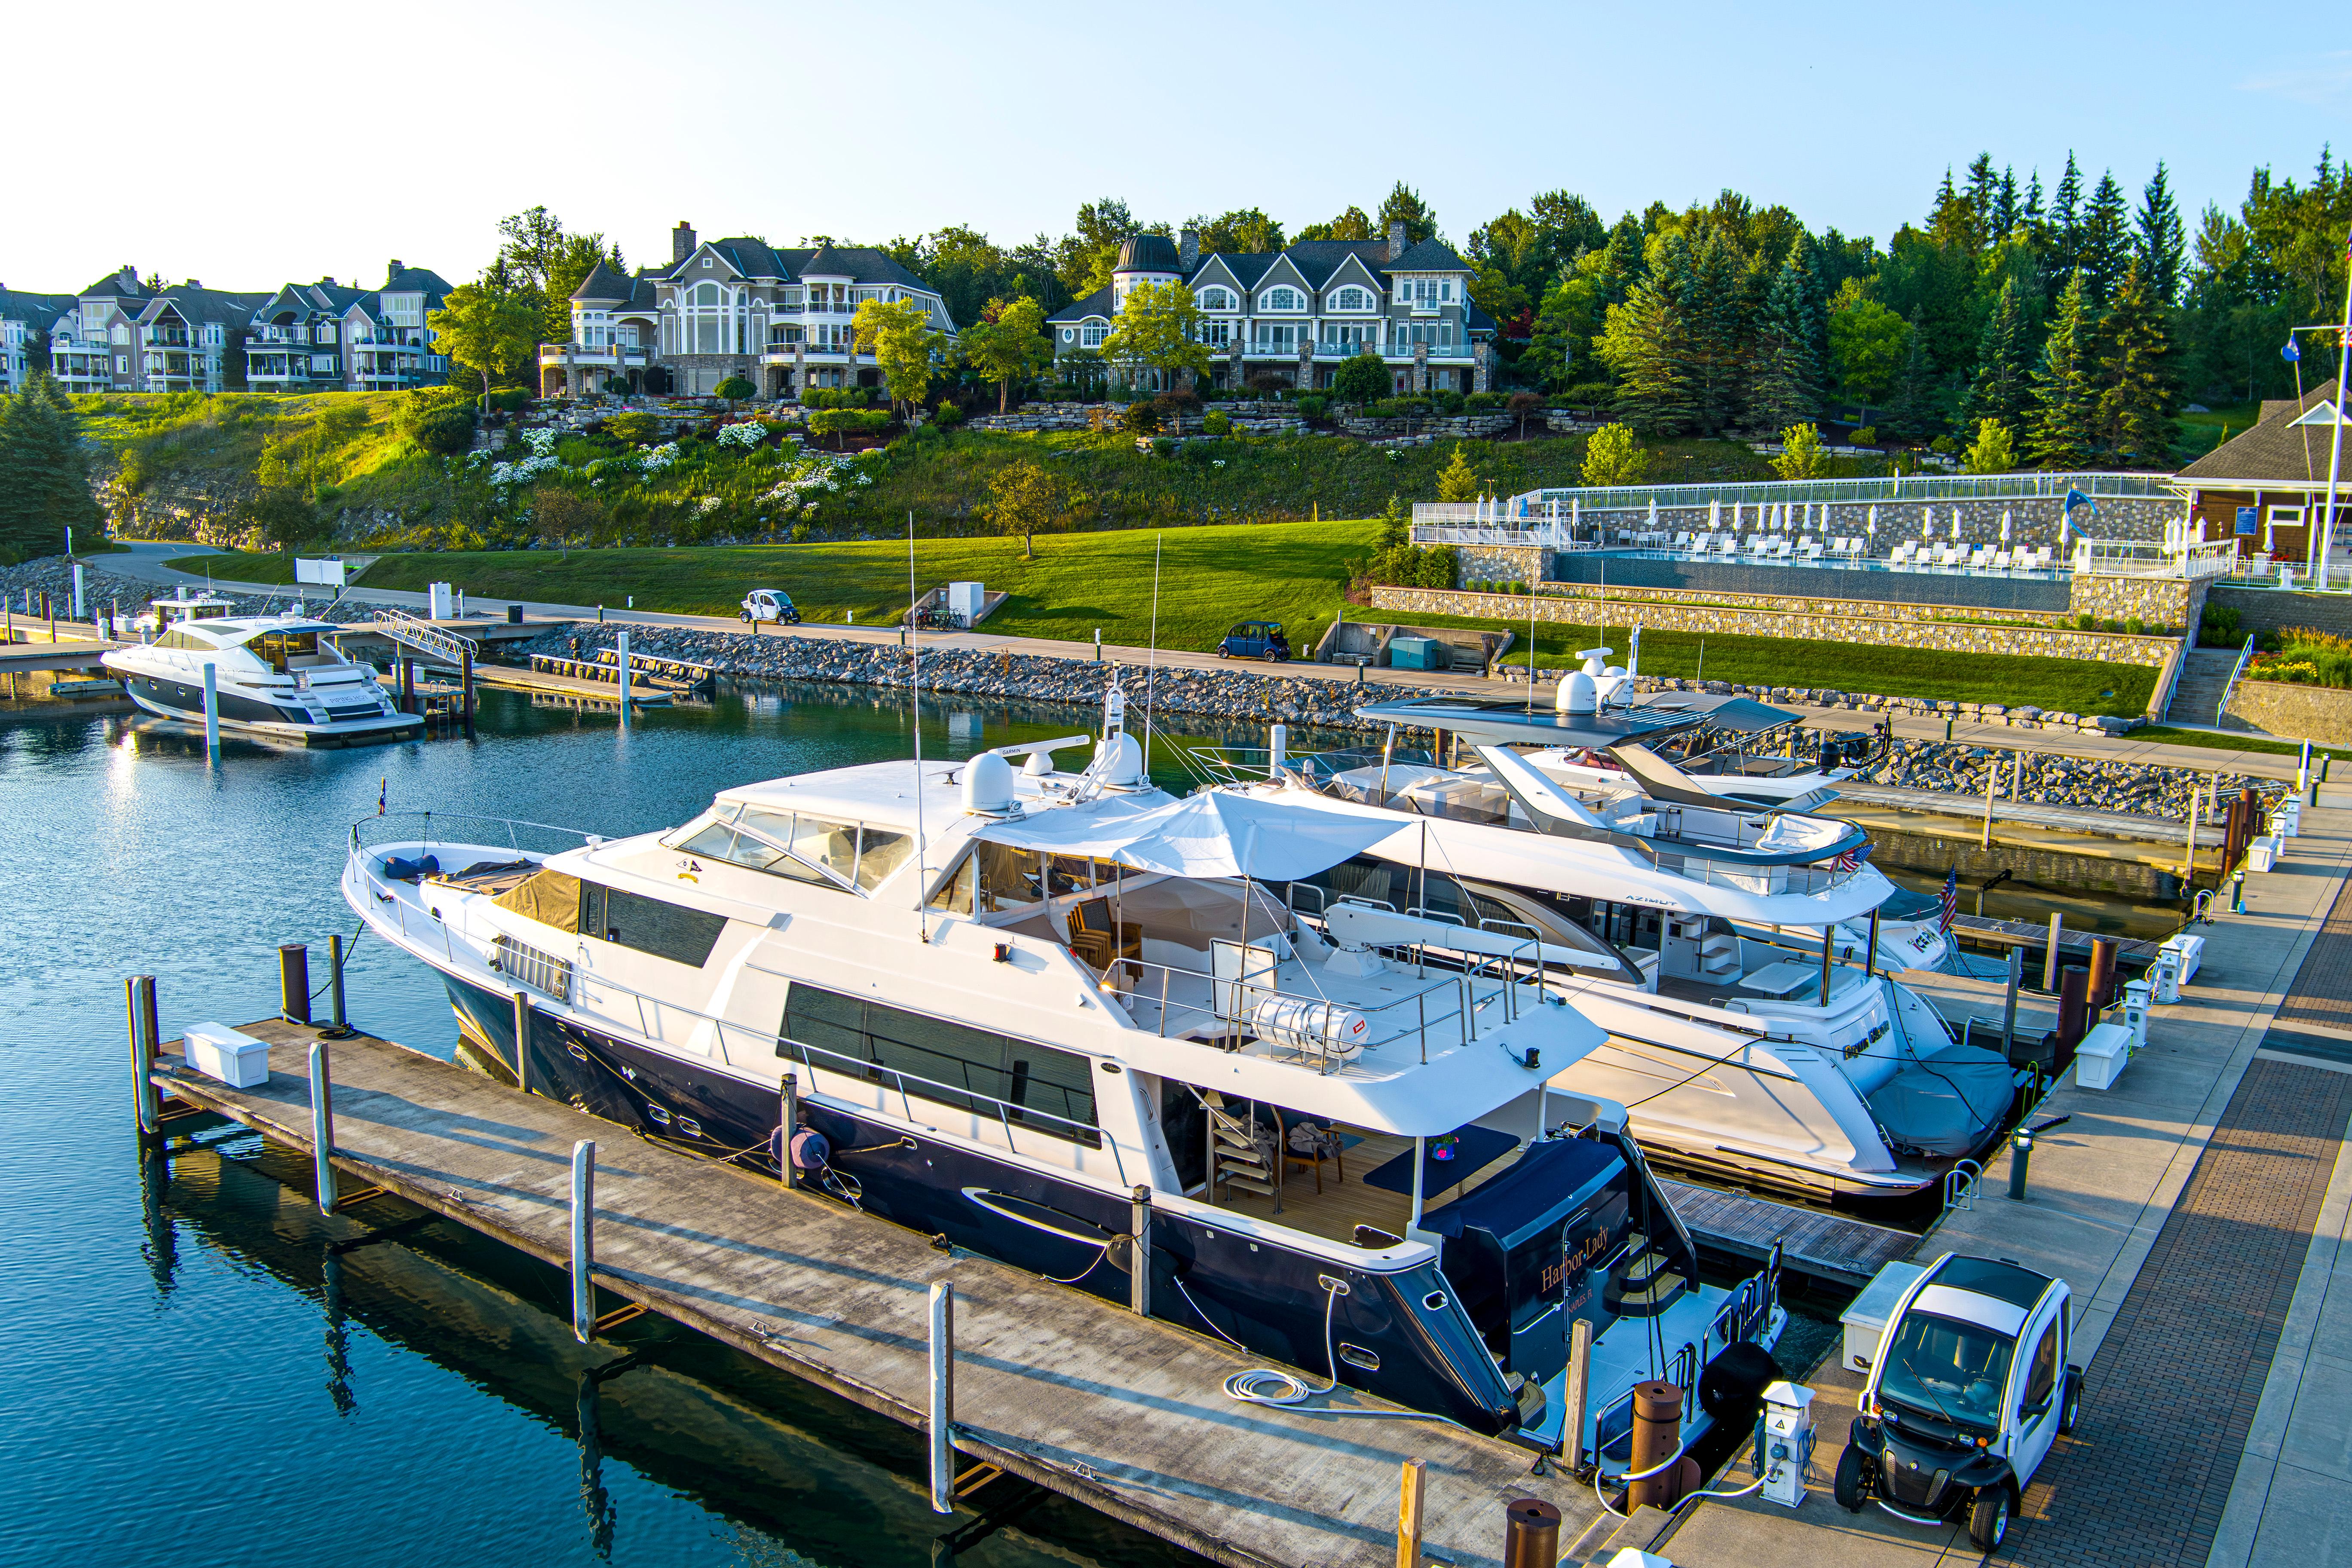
[343,705,1785,1462]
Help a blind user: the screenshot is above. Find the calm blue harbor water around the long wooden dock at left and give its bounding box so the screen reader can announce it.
[0,686,1197,1568]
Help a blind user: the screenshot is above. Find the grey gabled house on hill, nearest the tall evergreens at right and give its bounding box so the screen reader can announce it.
[1047,224,1496,392]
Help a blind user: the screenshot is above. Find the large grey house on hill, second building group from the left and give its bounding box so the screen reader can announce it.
[539,224,955,397]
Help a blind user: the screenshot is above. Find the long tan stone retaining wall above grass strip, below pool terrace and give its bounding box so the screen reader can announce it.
[1371,588,2176,668]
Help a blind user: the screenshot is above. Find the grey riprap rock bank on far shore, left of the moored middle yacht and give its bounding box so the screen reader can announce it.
[513,621,1458,726]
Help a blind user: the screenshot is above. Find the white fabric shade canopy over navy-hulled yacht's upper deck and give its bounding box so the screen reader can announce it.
[974,790,1395,882]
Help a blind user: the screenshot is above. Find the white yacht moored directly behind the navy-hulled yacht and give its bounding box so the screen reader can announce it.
[1202,701,2016,1199]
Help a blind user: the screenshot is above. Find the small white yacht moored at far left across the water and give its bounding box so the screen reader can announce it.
[104,597,423,745]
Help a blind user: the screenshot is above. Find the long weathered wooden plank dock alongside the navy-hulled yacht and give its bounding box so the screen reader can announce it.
[155,1020,1599,1568]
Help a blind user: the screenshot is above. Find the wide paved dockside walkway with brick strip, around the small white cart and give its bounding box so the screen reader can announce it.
[1654,790,2352,1568]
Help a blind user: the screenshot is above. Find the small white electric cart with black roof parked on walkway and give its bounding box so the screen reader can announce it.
[1834,1253,2082,1552]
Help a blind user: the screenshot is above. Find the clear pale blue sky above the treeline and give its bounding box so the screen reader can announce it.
[18,0,2352,291]
